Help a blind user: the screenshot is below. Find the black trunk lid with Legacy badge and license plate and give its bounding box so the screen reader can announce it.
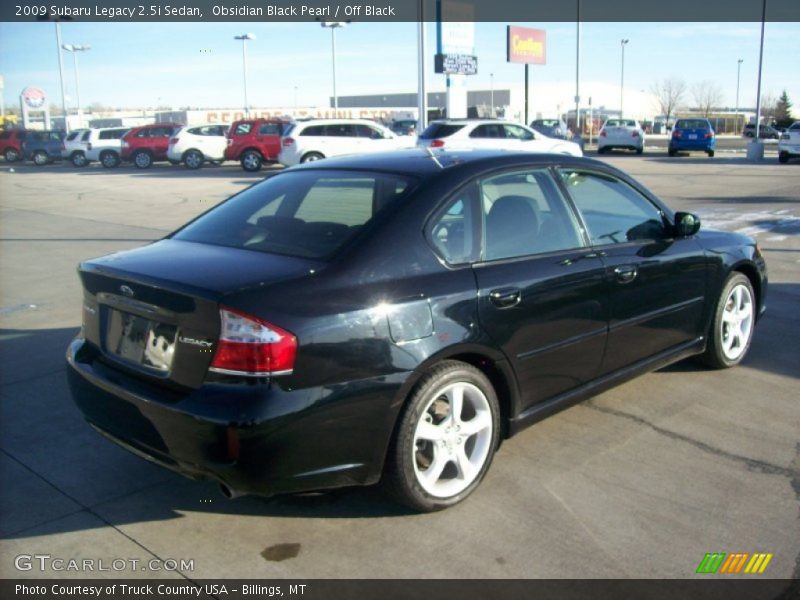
[79,239,322,388]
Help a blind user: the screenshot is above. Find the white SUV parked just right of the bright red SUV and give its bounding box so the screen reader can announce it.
[278,119,414,167]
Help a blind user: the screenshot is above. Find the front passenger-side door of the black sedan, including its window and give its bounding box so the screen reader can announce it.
[560,168,708,373]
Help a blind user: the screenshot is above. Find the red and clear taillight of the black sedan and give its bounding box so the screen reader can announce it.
[211,307,297,376]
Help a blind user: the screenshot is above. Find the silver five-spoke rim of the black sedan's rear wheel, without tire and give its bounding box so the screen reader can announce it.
[412,382,493,498]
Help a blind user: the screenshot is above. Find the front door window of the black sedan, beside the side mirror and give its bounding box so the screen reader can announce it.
[560,169,666,245]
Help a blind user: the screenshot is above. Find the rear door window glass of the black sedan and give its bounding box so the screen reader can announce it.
[480,169,584,260]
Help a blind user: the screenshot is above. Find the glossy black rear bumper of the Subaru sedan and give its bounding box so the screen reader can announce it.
[67,337,407,495]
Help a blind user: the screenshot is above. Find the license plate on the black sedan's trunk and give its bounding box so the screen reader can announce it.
[106,310,178,371]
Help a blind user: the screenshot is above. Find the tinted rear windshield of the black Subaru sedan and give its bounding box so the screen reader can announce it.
[173,170,412,258]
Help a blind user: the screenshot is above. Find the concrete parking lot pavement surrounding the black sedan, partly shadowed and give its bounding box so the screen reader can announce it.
[0,152,800,579]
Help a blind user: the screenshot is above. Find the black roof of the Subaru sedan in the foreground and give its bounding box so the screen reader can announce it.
[284,148,613,179]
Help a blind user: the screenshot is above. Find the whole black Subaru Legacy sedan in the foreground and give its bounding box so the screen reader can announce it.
[67,150,767,511]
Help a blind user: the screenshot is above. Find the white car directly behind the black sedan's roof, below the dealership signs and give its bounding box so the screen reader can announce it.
[417,119,583,156]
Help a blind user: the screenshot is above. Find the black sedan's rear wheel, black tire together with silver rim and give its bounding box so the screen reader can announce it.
[382,360,500,512]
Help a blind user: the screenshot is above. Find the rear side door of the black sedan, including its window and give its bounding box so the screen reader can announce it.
[473,168,607,411]
